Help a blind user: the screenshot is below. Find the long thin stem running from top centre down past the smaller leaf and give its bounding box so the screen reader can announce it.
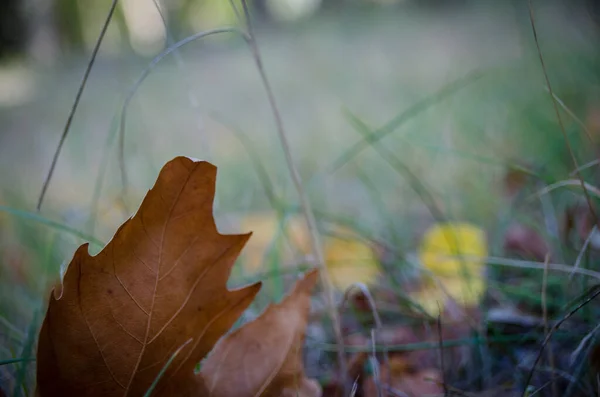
[242,0,350,386]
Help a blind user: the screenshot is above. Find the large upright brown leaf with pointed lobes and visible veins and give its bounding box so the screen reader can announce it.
[37,157,260,397]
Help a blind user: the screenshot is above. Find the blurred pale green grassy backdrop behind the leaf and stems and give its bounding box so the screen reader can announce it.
[0,0,600,392]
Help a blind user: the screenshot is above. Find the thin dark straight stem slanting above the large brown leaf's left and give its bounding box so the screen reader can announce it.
[36,0,118,211]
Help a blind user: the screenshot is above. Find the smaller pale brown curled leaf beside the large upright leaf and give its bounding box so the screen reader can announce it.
[201,270,321,397]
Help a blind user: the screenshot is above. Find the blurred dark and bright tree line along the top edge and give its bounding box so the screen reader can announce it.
[0,0,600,58]
